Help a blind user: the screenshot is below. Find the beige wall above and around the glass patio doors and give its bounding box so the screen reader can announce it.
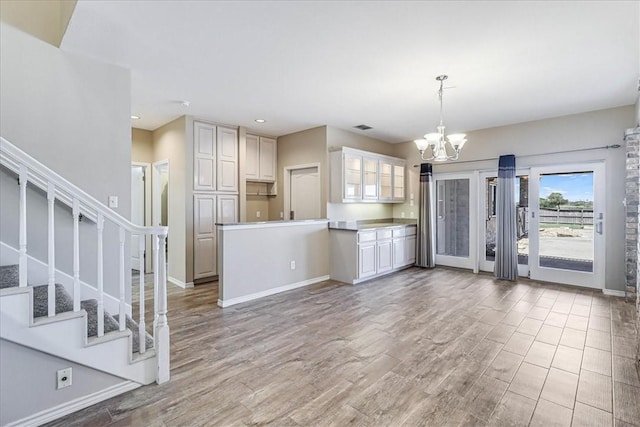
[394,106,635,290]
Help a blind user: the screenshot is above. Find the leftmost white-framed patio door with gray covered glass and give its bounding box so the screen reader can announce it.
[434,173,477,269]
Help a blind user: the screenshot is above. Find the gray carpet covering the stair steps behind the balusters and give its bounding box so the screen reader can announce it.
[0,265,153,353]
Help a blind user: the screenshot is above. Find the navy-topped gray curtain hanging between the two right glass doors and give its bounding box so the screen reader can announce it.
[494,154,518,280]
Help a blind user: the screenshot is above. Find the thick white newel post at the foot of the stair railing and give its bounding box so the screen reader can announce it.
[154,231,170,384]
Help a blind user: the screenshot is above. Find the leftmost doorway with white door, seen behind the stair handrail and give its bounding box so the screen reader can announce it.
[131,162,151,271]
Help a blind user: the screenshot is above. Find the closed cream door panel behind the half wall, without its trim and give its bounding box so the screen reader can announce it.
[289,167,320,219]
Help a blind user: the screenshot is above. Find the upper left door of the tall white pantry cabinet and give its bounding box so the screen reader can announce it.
[193,122,216,191]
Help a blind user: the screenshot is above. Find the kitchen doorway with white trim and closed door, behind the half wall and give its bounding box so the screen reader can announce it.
[284,164,322,220]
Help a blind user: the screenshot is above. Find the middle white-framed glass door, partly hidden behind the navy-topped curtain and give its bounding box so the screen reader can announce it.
[478,169,531,277]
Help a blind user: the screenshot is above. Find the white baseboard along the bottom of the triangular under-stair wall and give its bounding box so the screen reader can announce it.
[6,381,141,427]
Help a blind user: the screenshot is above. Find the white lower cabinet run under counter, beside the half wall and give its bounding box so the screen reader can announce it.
[330,226,416,284]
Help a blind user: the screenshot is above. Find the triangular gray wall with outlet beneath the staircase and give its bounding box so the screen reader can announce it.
[0,340,123,425]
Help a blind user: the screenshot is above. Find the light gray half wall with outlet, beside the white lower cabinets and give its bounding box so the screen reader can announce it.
[218,222,329,301]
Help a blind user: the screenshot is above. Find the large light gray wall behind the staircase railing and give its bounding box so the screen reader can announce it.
[0,23,131,295]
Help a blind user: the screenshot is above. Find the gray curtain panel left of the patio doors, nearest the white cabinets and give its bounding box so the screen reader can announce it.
[416,163,436,268]
